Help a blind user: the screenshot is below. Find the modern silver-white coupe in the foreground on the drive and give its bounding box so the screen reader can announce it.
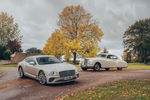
[18,55,79,85]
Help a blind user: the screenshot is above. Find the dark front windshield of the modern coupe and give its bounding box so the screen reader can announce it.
[36,57,62,65]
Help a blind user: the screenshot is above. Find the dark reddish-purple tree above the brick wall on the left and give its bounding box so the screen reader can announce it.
[7,40,22,53]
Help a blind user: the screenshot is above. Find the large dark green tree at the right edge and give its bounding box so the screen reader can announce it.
[123,18,150,63]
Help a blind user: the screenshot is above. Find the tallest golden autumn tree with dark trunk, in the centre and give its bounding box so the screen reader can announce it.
[58,5,103,62]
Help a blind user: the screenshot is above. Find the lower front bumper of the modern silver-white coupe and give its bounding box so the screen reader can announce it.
[47,73,79,84]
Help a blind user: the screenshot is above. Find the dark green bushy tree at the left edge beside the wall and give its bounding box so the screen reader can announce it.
[0,45,12,60]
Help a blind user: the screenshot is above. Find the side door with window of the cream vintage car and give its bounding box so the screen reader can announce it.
[107,55,117,67]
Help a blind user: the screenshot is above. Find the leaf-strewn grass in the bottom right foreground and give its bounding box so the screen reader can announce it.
[62,80,150,100]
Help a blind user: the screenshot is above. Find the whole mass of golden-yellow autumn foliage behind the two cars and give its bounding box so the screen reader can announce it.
[42,5,103,62]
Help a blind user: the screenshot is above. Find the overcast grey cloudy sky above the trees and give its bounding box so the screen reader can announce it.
[0,0,150,55]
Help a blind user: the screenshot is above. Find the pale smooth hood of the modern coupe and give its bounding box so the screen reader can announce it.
[39,63,76,72]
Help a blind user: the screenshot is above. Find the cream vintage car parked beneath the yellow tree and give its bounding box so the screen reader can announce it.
[79,53,128,71]
